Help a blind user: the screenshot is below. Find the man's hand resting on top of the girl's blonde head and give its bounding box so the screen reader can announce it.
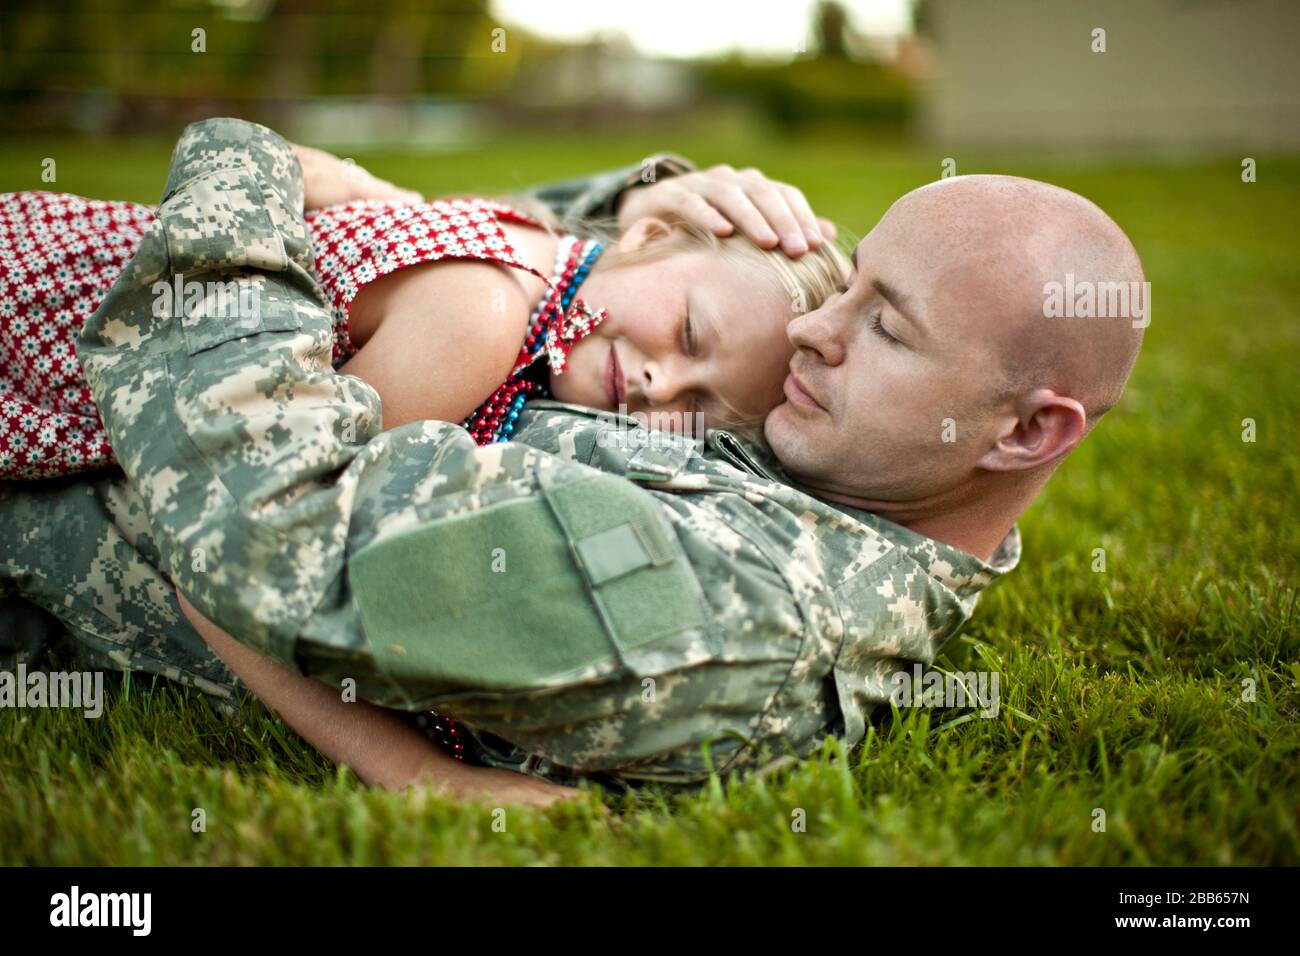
[619,164,835,256]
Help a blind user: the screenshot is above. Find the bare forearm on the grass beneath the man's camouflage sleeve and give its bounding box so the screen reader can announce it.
[177,591,581,806]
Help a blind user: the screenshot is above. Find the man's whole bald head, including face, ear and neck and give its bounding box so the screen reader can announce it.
[764,176,1149,532]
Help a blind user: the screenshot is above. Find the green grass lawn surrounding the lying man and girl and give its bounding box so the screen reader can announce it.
[0,133,1300,865]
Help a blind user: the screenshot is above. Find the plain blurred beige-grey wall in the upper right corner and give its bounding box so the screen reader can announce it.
[923,0,1300,155]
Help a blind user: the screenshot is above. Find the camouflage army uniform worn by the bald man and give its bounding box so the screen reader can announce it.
[0,120,1019,784]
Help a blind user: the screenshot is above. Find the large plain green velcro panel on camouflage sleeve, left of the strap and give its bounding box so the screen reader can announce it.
[348,496,616,696]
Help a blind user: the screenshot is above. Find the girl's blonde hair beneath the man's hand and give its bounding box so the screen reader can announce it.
[502,196,853,433]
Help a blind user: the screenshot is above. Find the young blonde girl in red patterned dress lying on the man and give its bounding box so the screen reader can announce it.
[0,140,849,479]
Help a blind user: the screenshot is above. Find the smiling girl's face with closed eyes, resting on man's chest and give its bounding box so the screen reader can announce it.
[551,224,794,434]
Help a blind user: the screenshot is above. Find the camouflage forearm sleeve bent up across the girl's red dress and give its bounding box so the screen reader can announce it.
[77,118,380,666]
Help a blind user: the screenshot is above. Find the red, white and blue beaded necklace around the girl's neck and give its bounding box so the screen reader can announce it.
[464,235,606,445]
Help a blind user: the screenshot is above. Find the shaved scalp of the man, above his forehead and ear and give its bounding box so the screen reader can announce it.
[887,176,1149,427]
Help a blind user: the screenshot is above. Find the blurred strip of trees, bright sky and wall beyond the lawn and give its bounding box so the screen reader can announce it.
[0,0,1300,178]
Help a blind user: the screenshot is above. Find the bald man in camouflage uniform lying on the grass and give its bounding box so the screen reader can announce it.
[0,120,1141,786]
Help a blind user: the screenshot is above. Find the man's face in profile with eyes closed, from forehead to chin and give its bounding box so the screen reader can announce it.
[764,198,1011,502]
